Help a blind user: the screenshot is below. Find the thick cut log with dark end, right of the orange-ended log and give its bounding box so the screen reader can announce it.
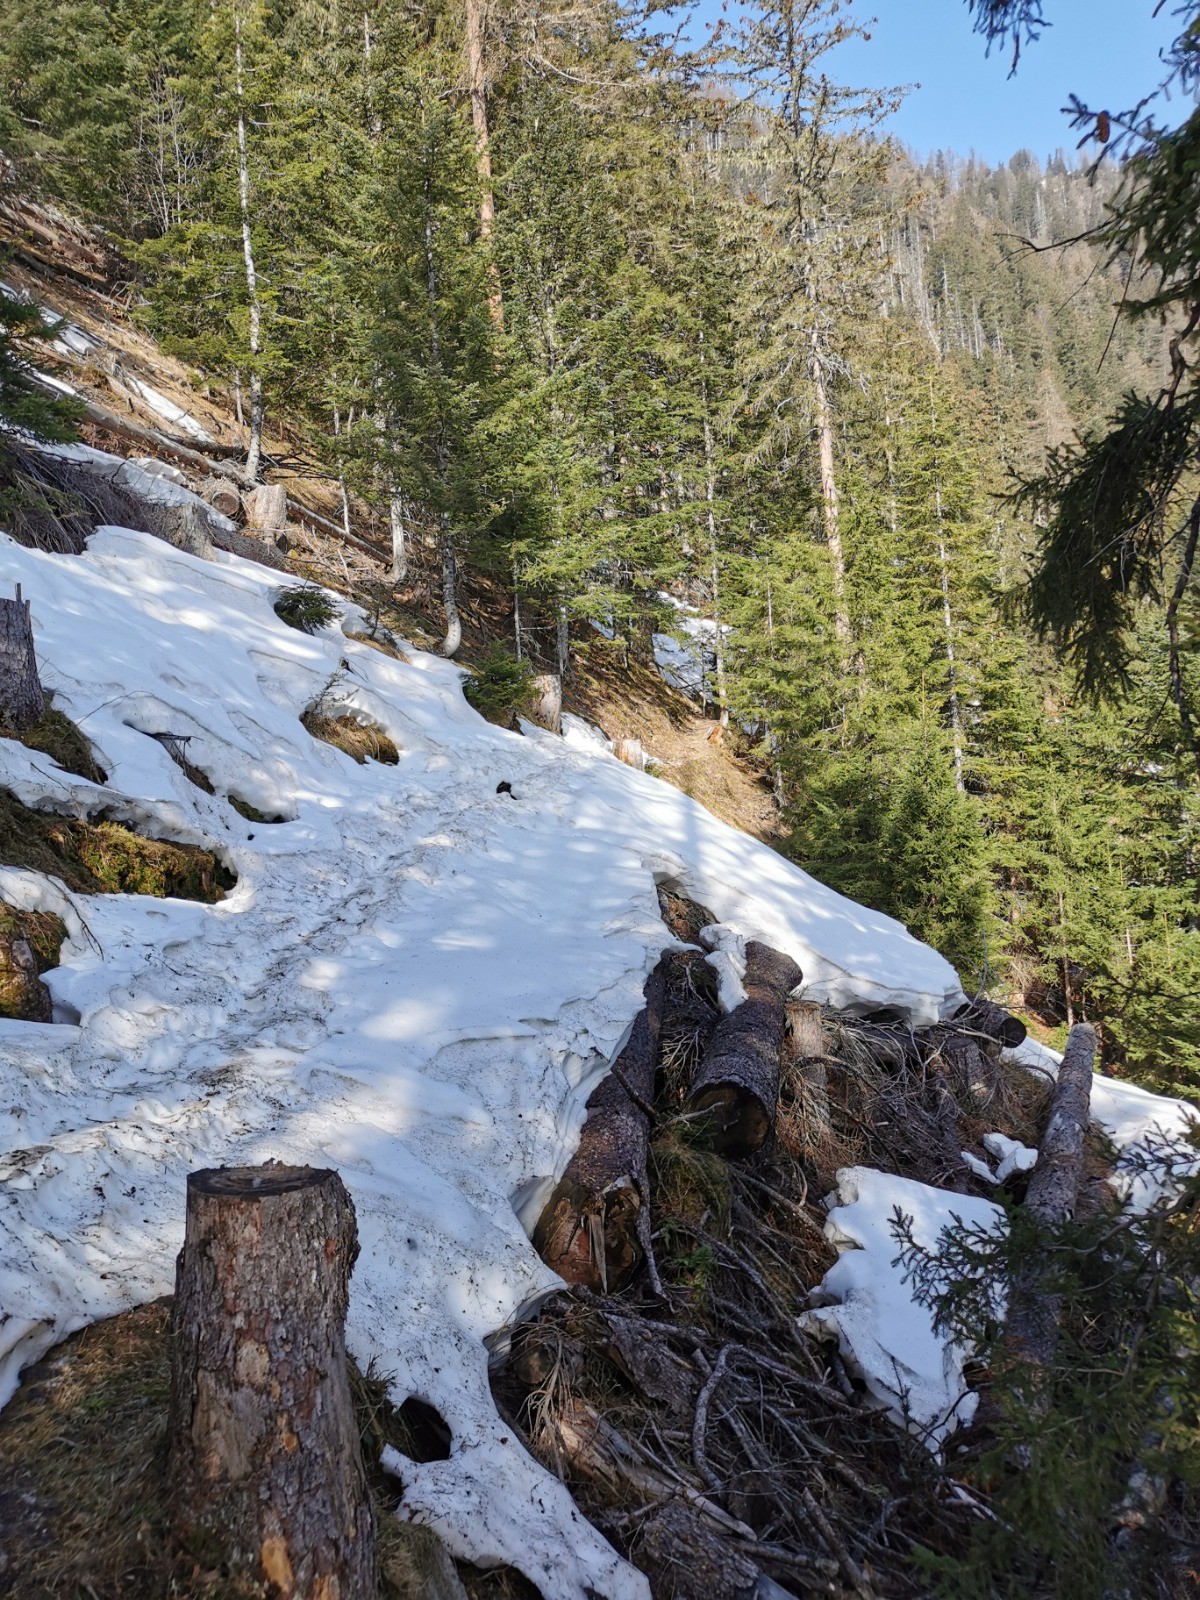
[688,939,803,1157]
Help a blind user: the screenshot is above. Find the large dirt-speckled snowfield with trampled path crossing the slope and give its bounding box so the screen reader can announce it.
[0,521,966,1600]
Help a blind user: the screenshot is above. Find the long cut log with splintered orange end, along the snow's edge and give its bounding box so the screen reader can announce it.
[533,957,669,1294]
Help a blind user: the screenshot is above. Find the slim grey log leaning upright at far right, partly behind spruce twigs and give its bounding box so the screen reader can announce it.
[1005,1022,1096,1369]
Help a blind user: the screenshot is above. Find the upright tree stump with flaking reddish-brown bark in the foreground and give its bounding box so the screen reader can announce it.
[170,1163,379,1600]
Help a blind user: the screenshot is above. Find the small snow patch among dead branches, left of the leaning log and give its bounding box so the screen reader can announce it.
[802,1163,1003,1450]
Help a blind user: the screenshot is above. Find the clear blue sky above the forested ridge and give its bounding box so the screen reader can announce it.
[684,0,1174,165]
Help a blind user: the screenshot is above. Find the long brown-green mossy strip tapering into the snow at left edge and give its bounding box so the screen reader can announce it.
[0,789,237,904]
